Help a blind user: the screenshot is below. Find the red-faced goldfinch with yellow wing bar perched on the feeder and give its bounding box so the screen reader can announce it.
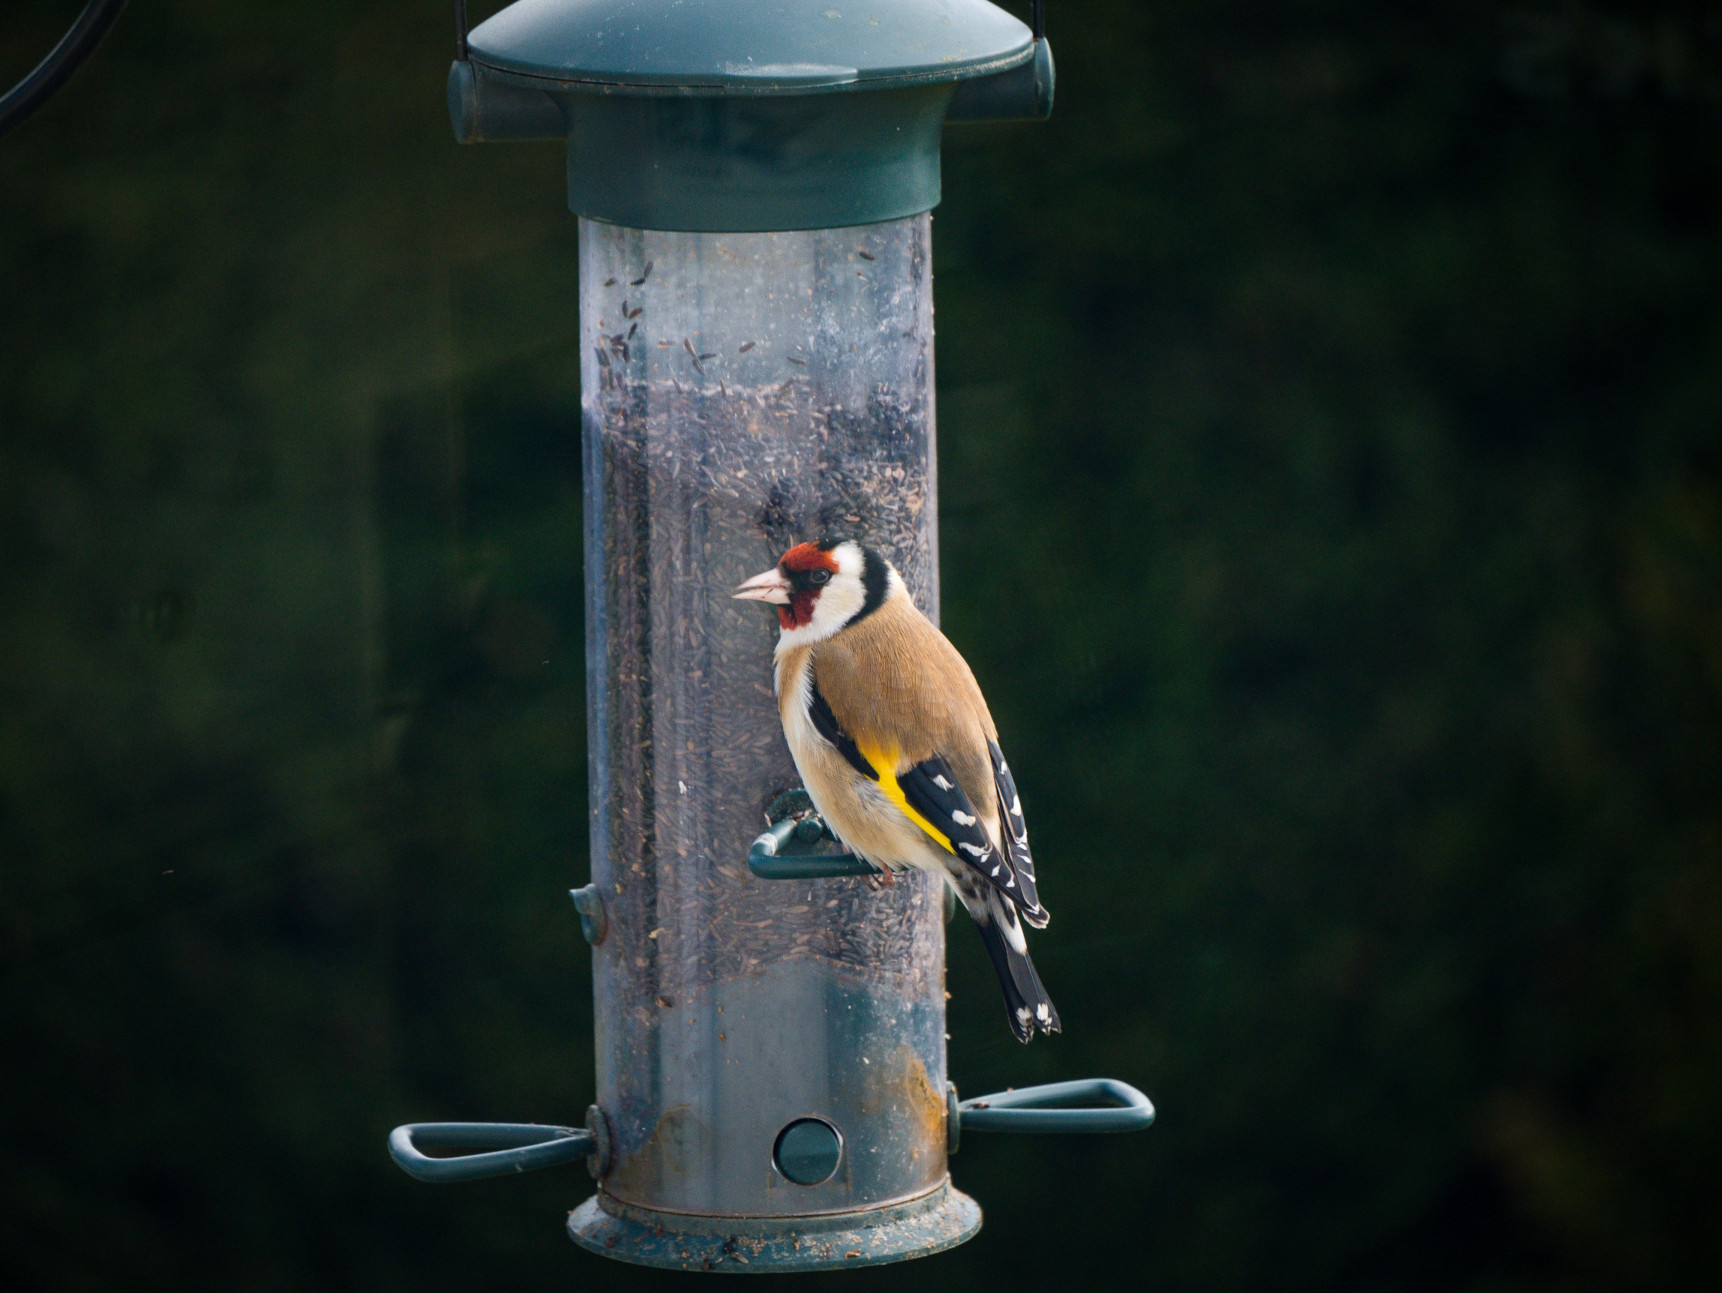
[734,539,1059,1042]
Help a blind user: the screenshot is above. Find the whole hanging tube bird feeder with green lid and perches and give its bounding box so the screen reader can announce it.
[389,0,1154,1272]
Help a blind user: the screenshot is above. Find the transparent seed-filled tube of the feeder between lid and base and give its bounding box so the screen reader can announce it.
[580,215,947,1217]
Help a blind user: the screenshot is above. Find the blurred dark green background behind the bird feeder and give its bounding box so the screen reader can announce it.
[0,0,1722,1293]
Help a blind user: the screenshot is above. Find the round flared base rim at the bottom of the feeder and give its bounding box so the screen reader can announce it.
[568,1181,980,1276]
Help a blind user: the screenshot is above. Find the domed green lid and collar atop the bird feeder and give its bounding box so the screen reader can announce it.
[449,0,1052,231]
